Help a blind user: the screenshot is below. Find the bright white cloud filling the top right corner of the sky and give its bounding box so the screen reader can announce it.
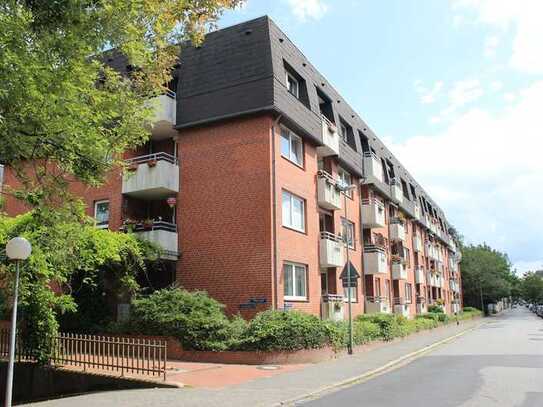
[452,0,543,74]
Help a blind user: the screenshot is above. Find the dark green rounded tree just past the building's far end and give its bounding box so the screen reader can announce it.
[461,244,515,307]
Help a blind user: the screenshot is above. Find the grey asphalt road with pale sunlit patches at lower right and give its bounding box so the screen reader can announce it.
[300,308,543,407]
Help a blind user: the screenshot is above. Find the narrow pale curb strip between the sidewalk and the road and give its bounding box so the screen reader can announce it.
[274,321,487,407]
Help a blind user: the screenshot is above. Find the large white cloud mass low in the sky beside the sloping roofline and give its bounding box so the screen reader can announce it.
[390,81,543,270]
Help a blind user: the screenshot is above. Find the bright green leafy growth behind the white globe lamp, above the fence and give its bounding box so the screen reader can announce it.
[0,207,157,362]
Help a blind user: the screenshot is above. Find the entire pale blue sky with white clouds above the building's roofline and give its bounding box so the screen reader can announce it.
[219,0,543,273]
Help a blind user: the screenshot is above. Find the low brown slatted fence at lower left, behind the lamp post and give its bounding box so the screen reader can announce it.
[0,330,167,380]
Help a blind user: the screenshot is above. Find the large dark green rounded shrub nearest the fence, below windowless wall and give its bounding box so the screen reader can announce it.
[129,288,241,351]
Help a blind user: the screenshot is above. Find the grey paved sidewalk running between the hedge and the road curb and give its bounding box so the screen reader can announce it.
[27,319,483,407]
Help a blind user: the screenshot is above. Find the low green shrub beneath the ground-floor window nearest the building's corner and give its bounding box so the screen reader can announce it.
[241,310,330,351]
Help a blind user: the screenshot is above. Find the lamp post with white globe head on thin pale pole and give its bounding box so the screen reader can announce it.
[4,237,32,407]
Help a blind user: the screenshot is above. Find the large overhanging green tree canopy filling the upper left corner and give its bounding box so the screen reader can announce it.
[0,0,241,204]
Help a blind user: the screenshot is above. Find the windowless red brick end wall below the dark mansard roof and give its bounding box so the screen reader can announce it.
[177,116,272,316]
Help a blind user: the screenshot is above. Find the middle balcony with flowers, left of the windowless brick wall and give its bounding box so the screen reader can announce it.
[122,153,179,200]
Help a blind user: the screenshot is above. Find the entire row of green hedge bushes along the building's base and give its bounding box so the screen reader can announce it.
[124,288,481,351]
